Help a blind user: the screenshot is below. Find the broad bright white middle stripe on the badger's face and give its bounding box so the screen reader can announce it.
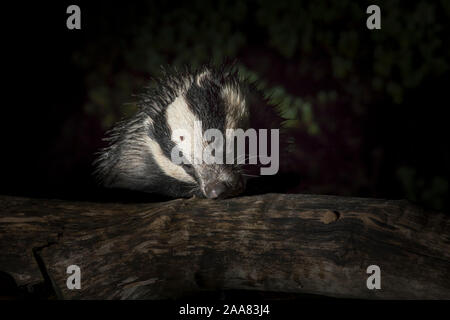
[166,96,207,163]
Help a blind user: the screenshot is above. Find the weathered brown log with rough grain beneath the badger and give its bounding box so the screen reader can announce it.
[0,194,450,299]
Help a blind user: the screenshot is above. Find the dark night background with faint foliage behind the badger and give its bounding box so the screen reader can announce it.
[0,0,450,212]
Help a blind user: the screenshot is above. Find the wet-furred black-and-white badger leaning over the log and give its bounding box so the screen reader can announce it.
[94,64,280,199]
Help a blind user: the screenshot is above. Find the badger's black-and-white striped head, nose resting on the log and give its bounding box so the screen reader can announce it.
[150,69,248,198]
